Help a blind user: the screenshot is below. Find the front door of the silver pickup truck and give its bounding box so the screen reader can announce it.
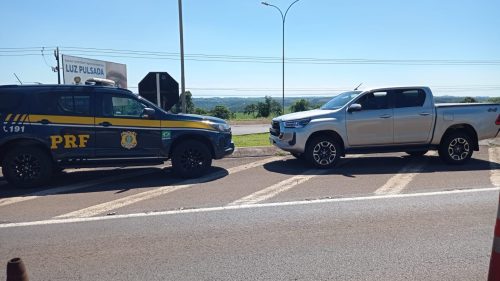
[346,91,394,146]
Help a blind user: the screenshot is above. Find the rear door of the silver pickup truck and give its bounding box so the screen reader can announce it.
[392,89,435,144]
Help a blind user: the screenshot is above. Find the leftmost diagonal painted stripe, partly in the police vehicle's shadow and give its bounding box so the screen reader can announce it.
[0,167,154,207]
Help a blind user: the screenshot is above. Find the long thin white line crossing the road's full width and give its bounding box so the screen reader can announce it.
[0,187,500,228]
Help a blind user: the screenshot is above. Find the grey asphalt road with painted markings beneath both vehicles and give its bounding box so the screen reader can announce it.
[0,146,500,280]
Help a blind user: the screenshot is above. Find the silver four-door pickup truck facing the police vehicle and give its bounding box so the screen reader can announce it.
[270,87,500,168]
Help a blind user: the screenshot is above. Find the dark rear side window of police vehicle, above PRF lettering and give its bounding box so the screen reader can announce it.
[33,92,91,116]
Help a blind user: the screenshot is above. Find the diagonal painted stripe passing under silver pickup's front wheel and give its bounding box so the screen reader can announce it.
[228,154,364,206]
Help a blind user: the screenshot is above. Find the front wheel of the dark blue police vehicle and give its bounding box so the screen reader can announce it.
[172,140,212,178]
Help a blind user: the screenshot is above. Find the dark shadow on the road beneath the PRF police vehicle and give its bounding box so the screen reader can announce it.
[0,167,228,199]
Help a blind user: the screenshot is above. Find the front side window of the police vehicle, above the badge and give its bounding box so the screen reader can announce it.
[102,94,146,118]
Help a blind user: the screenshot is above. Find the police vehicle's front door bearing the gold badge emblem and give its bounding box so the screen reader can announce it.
[95,92,161,158]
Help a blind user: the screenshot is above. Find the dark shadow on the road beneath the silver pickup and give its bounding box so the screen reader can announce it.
[264,156,500,177]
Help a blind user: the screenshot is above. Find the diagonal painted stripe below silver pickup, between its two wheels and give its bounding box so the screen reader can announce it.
[374,151,437,195]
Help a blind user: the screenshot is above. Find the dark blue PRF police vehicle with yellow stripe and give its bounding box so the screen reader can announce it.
[0,85,234,187]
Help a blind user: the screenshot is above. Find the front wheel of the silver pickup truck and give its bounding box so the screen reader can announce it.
[304,136,341,169]
